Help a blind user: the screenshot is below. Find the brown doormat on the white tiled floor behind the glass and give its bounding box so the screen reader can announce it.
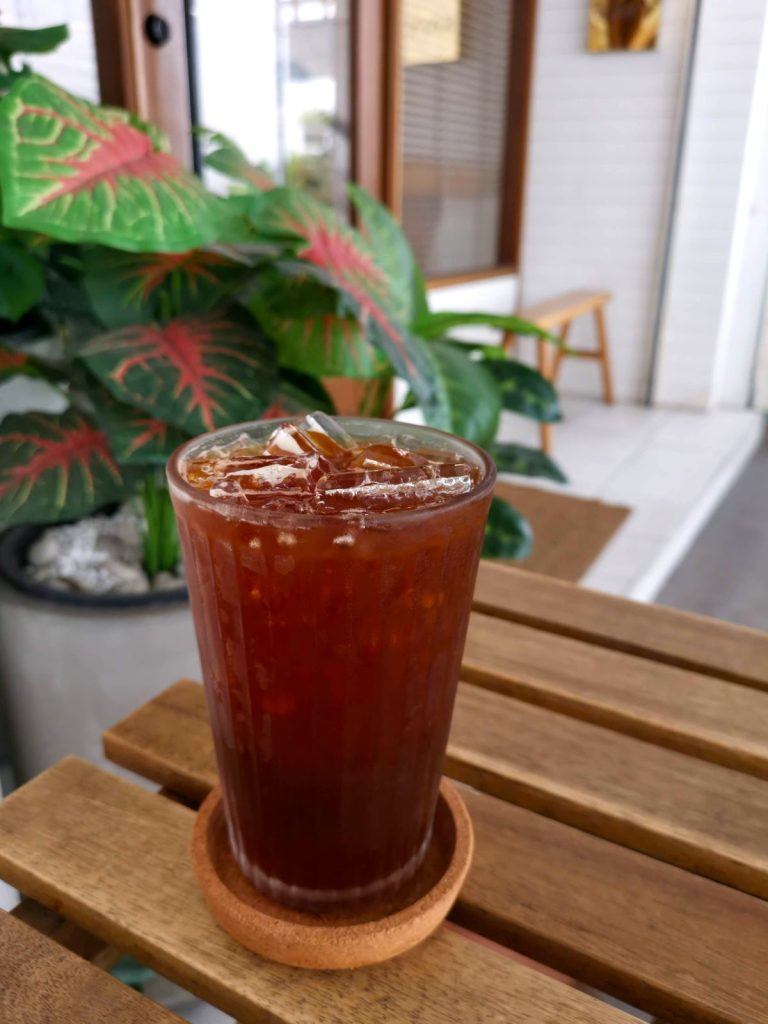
[496,483,632,583]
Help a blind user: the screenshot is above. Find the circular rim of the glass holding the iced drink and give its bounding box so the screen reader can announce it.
[166,415,497,528]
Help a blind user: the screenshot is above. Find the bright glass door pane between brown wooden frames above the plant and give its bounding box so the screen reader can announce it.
[193,0,350,211]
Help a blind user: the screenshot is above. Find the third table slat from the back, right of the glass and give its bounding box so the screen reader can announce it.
[447,684,768,898]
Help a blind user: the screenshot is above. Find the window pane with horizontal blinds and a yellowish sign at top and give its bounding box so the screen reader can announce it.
[402,0,513,275]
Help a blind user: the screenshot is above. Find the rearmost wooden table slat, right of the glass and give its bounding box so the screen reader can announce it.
[474,561,768,690]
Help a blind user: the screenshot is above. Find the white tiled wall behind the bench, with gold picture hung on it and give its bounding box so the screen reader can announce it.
[521,0,692,400]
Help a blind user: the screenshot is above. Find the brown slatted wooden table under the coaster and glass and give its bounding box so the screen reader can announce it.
[0,564,768,1024]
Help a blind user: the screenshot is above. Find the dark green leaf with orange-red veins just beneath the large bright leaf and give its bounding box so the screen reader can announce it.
[83,248,250,328]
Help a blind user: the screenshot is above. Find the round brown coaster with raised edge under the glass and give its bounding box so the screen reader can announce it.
[191,778,474,970]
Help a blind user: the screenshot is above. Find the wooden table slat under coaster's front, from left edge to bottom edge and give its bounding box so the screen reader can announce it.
[0,758,630,1024]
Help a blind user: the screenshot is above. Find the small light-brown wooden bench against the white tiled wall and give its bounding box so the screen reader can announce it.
[504,291,613,454]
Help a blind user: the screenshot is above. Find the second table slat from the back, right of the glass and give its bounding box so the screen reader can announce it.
[462,612,768,779]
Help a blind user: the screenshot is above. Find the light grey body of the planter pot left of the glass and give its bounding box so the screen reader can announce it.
[0,583,201,782]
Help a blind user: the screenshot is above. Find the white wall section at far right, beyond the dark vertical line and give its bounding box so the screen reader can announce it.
[653,0,768,408]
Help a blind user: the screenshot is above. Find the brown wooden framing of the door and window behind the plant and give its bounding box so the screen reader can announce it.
[91,0,538,274]
